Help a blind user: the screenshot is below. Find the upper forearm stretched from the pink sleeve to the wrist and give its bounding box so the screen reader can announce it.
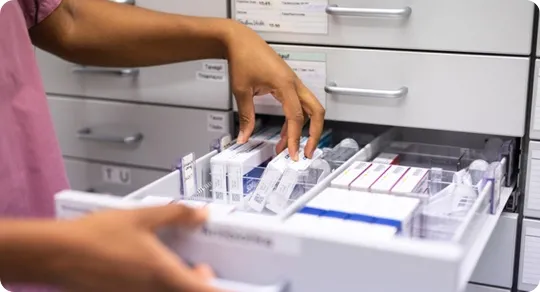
[31,0,236,67]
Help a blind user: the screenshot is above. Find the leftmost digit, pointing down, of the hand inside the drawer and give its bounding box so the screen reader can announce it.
[234,90,255,144]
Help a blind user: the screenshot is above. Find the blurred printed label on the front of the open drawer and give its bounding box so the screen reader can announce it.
[194,225,301,255]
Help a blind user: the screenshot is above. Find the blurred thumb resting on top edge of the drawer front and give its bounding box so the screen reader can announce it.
[134,204,208,230]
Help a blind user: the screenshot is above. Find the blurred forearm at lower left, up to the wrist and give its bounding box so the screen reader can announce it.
[0,219,66,284]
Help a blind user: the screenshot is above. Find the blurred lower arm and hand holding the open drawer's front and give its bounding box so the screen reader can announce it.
[0,205,216,292]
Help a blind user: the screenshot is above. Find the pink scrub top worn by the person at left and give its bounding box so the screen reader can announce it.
[0,0,69,292]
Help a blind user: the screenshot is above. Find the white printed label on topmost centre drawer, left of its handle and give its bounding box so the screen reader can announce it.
[233,0,328,34]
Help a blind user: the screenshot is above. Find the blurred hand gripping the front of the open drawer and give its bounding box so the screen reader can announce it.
[49,205,216,292]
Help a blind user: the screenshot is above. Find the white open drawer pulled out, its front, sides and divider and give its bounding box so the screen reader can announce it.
[56,126,513,292]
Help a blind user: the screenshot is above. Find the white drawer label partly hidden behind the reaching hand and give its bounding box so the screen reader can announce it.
[254,50,326,108]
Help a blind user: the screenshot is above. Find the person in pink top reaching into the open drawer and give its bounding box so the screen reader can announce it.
[0,0,324,292]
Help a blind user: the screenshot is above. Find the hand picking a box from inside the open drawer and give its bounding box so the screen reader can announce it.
[226,22,325,160]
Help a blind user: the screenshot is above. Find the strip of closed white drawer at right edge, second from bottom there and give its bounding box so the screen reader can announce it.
[523,142,540,218]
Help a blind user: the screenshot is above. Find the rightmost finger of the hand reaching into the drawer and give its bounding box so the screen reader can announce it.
[296,81,325,158]
